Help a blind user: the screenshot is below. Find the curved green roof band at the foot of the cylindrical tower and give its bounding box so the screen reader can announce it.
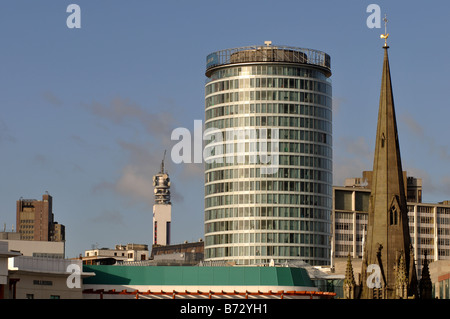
[83,265,314,287]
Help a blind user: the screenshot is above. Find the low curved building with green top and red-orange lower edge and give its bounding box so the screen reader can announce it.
[83,265,336,299]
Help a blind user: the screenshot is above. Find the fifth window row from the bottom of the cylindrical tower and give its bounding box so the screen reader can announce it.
[205,193,332,208]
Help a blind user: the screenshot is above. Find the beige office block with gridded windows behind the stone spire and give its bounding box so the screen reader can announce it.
[332,182,450,277]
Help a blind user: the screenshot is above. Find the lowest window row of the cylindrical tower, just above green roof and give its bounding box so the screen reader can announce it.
[205,245,329,265]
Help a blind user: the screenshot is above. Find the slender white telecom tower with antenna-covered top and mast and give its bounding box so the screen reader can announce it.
[153,153,172,245]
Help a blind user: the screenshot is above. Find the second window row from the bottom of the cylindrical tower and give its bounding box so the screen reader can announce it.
[205,231,326,246]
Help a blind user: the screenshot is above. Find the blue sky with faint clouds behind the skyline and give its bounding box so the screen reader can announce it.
[0,0,450,258]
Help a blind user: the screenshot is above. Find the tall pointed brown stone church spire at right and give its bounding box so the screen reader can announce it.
[361,44,417,299]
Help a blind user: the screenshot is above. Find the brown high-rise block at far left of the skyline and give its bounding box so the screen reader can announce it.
[16,193,65,241]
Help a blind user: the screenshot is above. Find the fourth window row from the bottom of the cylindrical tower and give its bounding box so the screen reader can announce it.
[205,205,330,221]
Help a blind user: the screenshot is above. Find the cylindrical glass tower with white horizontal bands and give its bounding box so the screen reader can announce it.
[205,41,332,265]
